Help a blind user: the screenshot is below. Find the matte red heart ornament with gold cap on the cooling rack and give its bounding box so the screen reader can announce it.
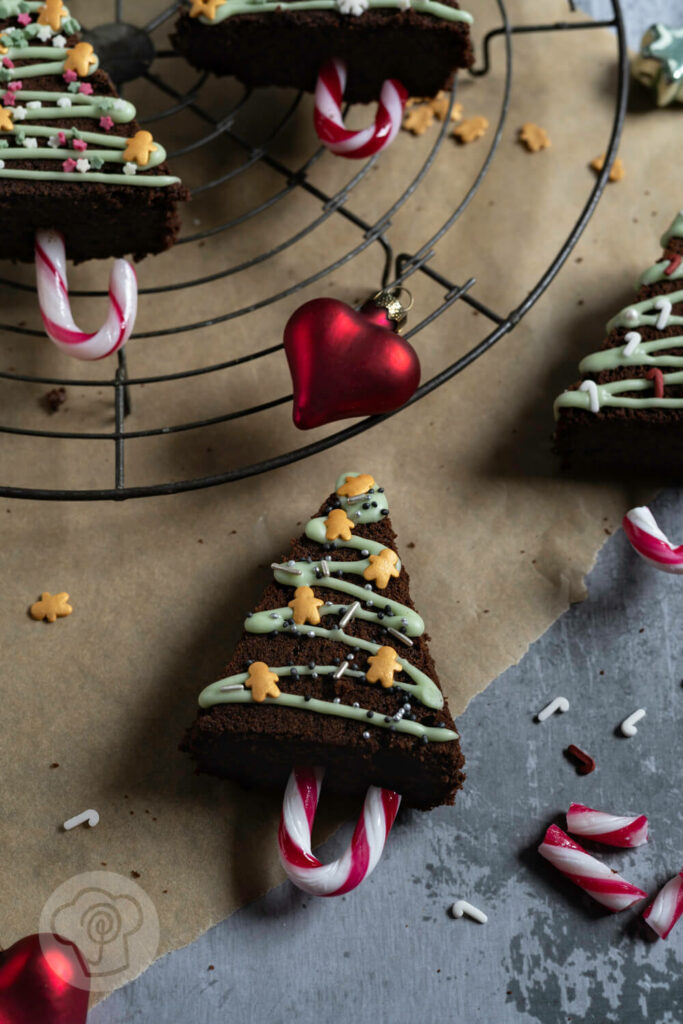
[285,299,420,430]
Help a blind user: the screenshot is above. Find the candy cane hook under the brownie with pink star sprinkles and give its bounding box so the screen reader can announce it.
[36,230,137,359]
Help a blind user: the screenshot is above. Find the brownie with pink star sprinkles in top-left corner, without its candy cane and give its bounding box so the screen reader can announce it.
[0,0,187,260]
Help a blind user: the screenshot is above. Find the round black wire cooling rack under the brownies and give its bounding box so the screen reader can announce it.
[0,0,628,501]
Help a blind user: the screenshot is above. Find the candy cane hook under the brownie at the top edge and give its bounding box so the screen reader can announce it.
[313,58,408,160]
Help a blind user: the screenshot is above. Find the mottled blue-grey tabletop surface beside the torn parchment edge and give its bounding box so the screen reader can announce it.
[89,0,683,1024]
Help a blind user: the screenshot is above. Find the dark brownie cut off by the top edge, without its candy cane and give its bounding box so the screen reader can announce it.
[172,0,474,103]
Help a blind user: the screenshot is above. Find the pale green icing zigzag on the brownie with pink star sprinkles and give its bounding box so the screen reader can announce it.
[0,0,180,187]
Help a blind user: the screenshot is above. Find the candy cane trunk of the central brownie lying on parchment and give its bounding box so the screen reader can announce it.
[278,768,400,896]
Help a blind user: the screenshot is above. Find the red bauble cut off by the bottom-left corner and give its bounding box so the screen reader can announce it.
[0,934,88,1024]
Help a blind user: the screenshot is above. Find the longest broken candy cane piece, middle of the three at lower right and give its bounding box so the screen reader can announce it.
[539,825,647,912]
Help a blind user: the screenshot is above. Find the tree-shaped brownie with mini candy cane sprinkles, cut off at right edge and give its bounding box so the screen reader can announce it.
[555,211,683,478]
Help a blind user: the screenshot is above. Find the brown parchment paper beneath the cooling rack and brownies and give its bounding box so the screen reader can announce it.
[0,0,681,995]
